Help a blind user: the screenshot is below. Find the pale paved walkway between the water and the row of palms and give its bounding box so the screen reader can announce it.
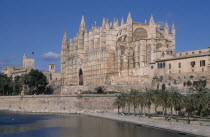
[84,113,210,137]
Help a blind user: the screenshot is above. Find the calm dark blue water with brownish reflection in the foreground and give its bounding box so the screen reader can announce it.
[0,112,196,137]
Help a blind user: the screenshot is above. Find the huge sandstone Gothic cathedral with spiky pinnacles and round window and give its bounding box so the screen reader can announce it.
[61,13,175,86]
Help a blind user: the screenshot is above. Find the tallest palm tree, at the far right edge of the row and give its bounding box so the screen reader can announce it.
[191,82,209,118]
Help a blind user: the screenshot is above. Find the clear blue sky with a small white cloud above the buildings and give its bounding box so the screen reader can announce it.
[0,0,210,71]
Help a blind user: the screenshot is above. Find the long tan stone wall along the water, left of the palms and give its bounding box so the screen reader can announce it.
[0,95,116,113]
